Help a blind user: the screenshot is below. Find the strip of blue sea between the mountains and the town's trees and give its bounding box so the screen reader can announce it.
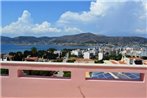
[1,44,88,53]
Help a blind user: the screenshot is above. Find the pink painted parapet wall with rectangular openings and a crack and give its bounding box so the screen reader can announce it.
[0,62,147,98]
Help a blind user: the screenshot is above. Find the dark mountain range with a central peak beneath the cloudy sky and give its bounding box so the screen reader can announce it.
[1,33,147,45]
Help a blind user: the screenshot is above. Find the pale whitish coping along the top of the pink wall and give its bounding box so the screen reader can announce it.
[0,61,147,69]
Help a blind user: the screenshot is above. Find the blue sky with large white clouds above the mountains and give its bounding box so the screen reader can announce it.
[0,0,147,38]
